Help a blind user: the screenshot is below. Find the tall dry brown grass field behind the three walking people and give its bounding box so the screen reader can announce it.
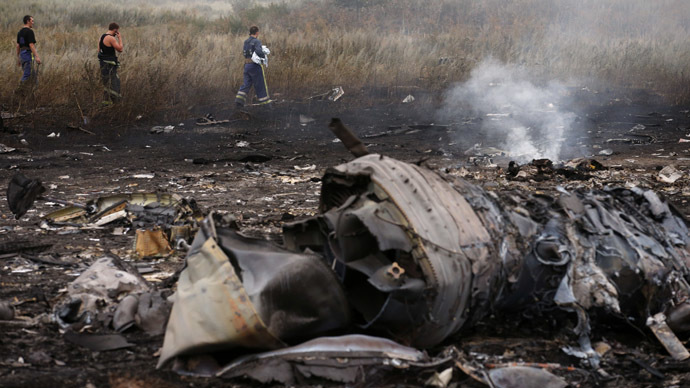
[0,0,690,119]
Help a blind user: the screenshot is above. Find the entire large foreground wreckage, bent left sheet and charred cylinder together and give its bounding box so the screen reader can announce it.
[158,119,690,383]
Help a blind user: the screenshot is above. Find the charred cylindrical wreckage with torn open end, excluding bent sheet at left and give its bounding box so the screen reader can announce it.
[300,155,690,346]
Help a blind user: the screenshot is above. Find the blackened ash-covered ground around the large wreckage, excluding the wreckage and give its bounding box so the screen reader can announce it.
[0,89,690,387]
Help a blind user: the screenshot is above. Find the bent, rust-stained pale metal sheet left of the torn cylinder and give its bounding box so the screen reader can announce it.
[158,215,350,367]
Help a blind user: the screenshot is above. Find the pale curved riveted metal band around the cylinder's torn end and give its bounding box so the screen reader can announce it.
[322,154,492,347]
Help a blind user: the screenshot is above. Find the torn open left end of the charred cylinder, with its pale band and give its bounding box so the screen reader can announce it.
[304,155,491,347]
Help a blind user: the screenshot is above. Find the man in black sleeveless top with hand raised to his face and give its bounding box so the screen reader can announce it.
[98,23,124,105]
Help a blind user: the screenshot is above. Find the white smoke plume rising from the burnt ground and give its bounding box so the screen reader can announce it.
[440,60,576,162]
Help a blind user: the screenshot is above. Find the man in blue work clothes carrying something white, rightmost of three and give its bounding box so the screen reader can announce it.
[235,26,271,108]
